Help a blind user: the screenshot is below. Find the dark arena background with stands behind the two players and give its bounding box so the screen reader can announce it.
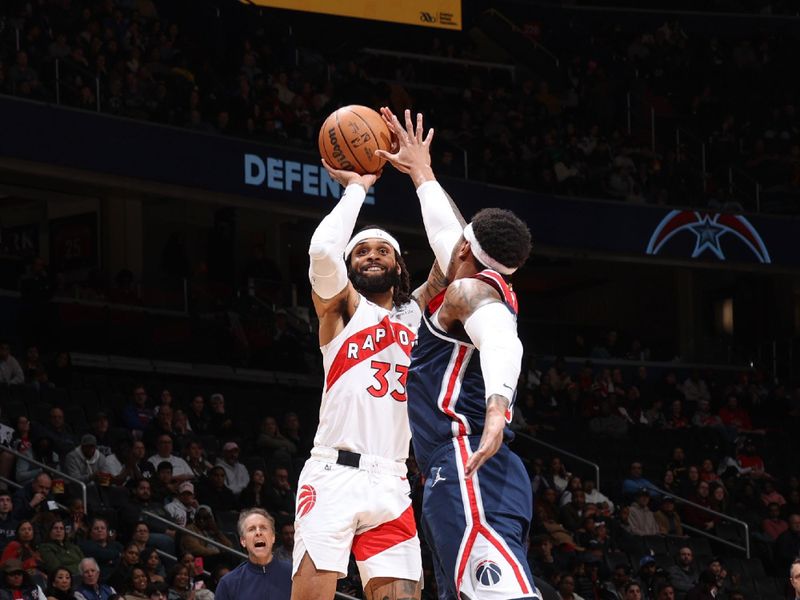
[0,0,800,600]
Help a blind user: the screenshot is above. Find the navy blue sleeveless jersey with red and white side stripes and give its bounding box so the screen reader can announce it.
[407,269,518,473]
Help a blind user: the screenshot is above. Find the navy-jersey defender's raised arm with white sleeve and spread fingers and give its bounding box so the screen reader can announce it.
[377,107,466,306]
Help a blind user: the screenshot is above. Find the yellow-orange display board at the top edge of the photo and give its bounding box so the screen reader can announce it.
[245,0,461,30]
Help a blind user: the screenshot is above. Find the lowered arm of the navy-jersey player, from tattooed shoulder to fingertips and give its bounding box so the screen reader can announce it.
[439,279,522,477]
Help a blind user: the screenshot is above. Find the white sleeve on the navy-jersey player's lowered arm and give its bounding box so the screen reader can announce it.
[464,302,522,403]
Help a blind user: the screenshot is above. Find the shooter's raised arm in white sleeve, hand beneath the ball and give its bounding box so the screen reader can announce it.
[308,160,378,346]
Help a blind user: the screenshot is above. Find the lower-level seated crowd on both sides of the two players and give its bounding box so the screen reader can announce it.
[0,340,800,600]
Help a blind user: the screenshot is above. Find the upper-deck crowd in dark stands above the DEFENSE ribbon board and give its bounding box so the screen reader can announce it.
[0,0,800,209]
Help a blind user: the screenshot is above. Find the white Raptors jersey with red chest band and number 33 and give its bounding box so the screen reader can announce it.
[314,296,421,461]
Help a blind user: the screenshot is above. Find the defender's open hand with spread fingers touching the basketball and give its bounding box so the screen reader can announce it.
[375,106,434,187]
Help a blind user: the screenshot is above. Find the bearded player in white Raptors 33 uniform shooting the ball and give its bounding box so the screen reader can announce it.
[292,161,443,600]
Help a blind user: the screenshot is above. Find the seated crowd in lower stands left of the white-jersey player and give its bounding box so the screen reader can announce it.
[0,364,310,600]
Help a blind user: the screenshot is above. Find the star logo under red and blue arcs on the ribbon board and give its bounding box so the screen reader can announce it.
[647,210,772,264]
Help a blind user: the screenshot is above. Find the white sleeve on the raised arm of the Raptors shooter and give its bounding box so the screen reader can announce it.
[308,184,367,300]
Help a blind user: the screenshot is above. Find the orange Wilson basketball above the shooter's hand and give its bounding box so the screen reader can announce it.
[319,104,391,175]
